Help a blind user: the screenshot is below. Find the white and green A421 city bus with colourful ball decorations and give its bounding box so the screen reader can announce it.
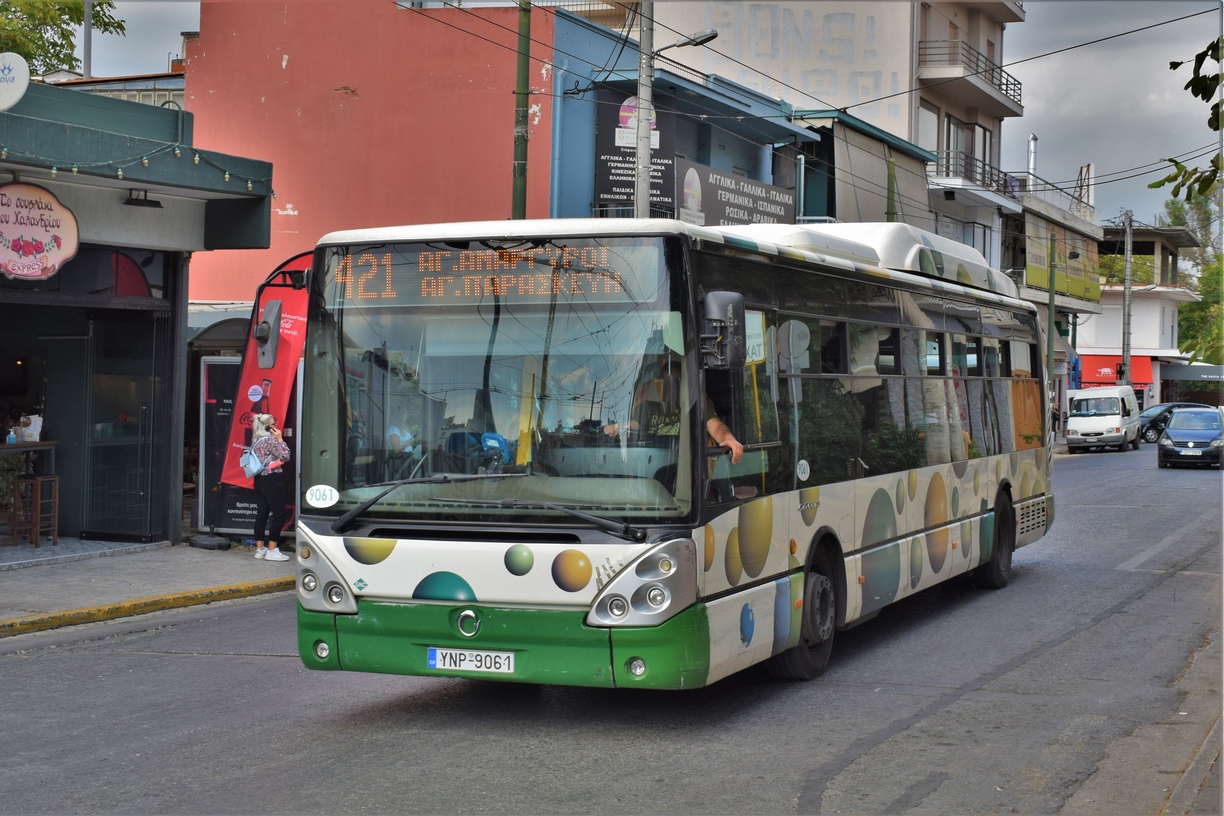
[296,219,1054,689]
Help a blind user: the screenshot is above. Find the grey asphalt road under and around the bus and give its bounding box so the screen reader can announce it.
[0,445,1222,816]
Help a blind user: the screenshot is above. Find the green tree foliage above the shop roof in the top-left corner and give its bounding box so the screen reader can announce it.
[0,0,125,76]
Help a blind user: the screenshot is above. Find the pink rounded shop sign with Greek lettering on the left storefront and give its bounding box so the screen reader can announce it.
[0,184,80,280]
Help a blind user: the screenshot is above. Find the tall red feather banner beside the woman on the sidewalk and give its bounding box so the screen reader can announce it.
[222,252,311,488]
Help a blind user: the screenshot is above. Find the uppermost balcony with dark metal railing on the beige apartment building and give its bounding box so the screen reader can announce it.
[918,39,1024,117]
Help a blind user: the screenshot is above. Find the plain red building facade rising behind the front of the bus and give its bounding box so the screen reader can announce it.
[185,0,554,301]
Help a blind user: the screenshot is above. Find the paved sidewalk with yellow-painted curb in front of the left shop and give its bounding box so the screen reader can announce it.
[0,538,297,637]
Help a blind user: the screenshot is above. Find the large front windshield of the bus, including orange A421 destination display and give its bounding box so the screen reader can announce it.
[302,237,695,524]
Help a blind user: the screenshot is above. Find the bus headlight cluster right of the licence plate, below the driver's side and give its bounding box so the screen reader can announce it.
[586,538,696,626]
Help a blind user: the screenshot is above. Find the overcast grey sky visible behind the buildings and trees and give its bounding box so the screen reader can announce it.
[77,0,1224,224]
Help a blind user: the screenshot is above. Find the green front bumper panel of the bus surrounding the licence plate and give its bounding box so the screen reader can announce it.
[297,602,710,689]
